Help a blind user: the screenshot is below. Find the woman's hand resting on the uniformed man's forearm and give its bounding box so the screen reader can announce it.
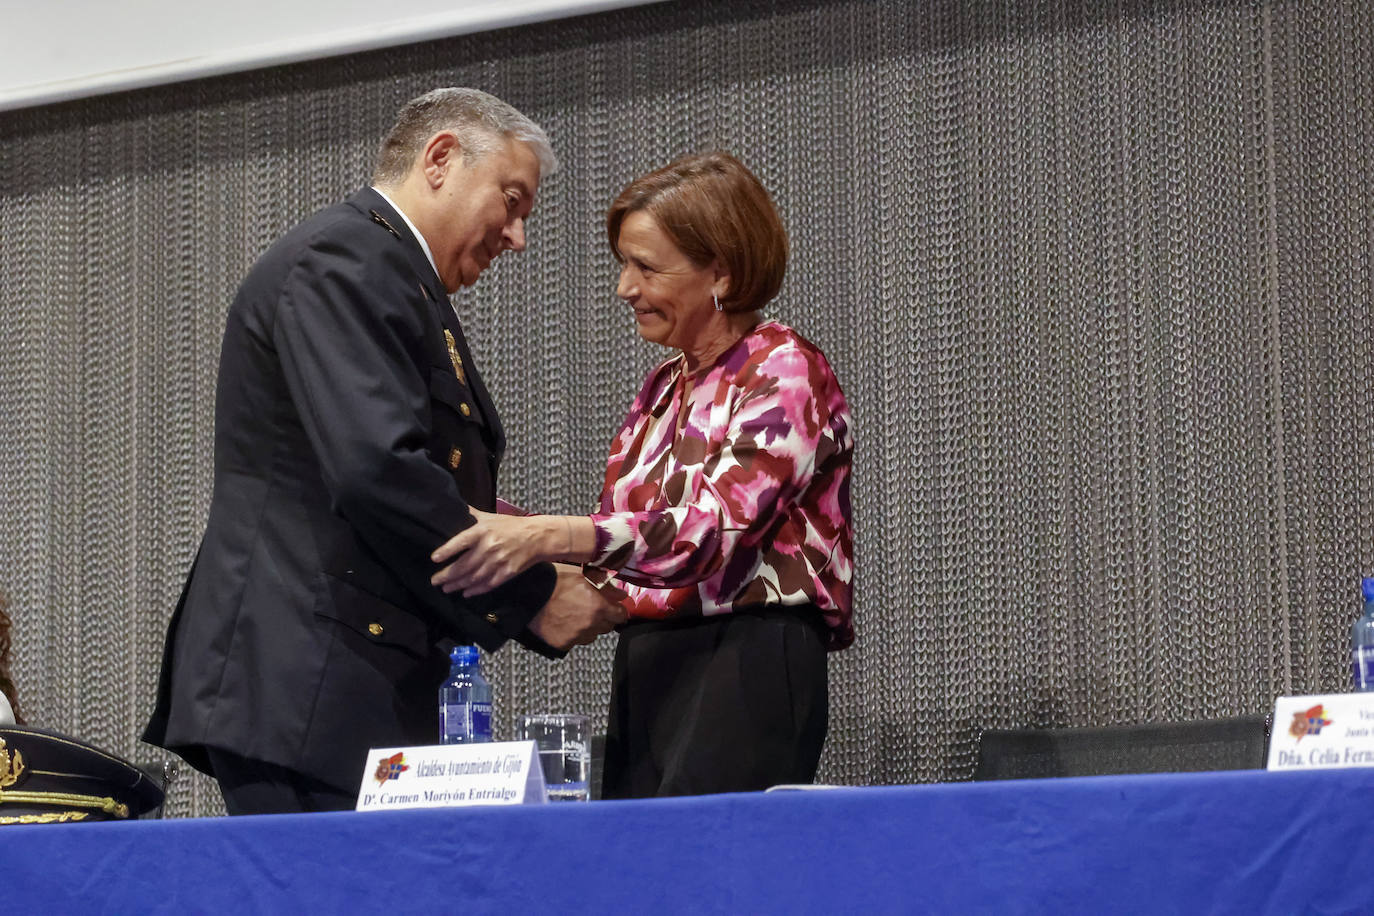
[430,508,551,595]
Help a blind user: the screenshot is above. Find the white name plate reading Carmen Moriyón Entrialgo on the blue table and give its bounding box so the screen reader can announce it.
[357,742,548,812]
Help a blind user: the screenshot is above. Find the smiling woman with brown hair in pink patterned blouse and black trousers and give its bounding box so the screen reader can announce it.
[433,152,853,798]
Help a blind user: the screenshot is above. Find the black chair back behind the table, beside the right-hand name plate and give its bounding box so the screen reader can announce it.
[973,715,1268,780]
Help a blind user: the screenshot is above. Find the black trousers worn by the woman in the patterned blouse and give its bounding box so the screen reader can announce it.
[602,606,830,798]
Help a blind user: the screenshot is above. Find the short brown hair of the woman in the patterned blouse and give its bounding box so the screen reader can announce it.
[606,151,787,312]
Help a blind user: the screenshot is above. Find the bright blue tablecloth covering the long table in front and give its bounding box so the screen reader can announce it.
[0,769,1374,915]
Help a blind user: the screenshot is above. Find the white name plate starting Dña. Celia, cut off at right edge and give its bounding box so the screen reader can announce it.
[1268,694,1374,770]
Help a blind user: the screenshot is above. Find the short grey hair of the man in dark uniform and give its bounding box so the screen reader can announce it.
[372,87,558,187]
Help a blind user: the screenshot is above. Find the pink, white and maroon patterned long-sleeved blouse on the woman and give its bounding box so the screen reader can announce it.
[587,321,853,650]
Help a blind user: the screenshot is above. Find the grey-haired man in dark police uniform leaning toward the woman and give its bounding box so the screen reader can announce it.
[143,89,622,814]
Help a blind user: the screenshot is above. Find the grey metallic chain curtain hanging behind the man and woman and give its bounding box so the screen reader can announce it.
[0,0,1374,814]
